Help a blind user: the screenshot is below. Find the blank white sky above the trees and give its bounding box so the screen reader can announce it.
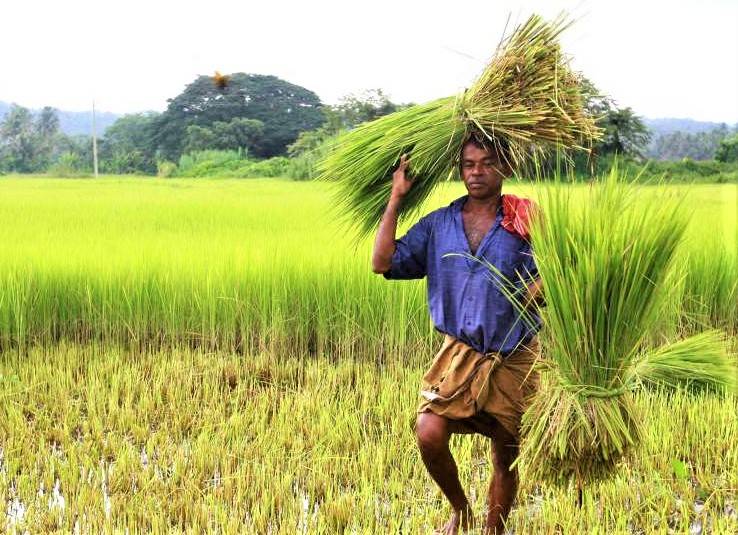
[0,0,738,123]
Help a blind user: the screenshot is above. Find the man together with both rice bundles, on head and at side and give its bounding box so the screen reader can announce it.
[321,15,738,533]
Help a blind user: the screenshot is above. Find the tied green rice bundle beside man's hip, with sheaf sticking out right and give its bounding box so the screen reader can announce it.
[508,168,736,488]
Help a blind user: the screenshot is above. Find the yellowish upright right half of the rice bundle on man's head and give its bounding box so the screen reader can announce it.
[462,15,598,161]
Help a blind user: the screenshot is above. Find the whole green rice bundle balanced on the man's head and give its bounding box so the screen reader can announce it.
[319,15,599,239]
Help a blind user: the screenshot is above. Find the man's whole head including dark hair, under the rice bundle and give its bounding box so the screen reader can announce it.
[459,135,512,200]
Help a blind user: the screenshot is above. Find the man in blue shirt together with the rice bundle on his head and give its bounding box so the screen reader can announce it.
[321,15,599,533]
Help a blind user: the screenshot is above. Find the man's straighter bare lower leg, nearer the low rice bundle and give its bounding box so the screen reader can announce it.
[484,422,518,535]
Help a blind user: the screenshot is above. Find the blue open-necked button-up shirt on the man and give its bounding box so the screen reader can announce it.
[384,196,540,355]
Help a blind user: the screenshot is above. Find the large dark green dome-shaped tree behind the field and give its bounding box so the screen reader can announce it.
[155,73,323,160]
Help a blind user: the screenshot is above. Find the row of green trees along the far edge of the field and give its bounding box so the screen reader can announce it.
[0,73,738,179]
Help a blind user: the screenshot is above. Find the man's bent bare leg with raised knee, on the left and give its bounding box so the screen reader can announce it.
[415,412,474,535]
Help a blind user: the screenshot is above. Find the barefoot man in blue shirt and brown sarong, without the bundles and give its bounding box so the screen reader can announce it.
[372,136,540,533]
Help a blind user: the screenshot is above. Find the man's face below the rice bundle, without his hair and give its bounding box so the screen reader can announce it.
[461,143,510,200]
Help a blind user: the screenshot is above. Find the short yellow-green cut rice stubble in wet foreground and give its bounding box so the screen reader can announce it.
[0,344,738,535]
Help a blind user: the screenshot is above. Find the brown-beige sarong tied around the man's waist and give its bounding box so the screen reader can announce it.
[418,335,540,438]
